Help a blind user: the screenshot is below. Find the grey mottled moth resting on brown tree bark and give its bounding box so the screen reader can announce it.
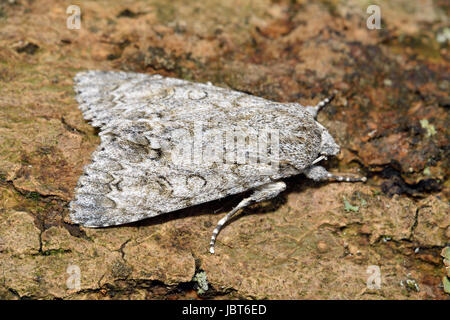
[69,71,366,253]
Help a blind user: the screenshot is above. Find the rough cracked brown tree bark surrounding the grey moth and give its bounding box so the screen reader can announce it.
[0,0,450,299]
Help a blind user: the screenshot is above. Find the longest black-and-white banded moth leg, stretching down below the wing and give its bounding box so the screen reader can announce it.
[209,181,286,253]
